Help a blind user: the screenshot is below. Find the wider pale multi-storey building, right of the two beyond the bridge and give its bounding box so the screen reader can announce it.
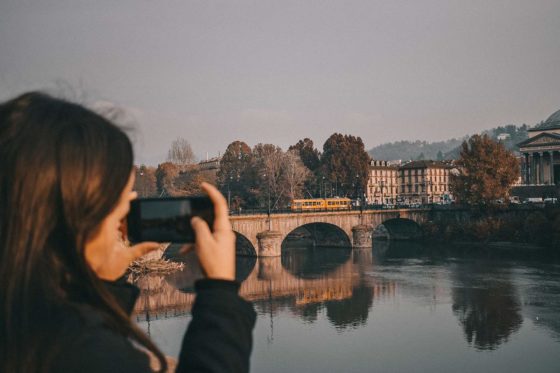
[398,161,453,204]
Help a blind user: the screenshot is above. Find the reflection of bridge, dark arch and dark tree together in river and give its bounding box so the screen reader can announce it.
[135,248,396,330]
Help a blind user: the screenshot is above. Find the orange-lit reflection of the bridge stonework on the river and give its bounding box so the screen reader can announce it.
[134,248,398,321]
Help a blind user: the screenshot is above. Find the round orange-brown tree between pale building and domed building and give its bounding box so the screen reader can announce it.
[450,135,520,205]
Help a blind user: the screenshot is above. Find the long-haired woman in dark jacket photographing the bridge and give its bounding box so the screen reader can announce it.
[0,92,255,373]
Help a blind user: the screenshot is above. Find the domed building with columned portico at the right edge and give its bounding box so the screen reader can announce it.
[518,110,560,185]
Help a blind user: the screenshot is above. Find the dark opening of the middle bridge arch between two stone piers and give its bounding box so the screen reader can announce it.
[282,222,352,250]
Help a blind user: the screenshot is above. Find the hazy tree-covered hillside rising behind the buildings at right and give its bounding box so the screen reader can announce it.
[368,124,529,161]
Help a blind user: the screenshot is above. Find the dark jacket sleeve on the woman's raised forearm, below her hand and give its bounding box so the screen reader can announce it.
[177,279,256,373]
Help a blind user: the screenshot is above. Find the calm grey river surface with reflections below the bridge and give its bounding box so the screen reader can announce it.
[137,243,560,373]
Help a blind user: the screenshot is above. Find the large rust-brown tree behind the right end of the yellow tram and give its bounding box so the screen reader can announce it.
[320,133,371,196]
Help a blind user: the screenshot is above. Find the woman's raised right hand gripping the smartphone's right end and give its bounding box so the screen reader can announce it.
[191,183,235,280]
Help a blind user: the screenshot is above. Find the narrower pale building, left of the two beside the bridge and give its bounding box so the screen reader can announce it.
[366,160,399,205]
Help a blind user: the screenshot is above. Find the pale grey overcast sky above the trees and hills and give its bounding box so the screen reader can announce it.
[0,0,560,164]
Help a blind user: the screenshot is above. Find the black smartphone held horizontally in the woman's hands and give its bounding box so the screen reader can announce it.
[127,196,214,243]
